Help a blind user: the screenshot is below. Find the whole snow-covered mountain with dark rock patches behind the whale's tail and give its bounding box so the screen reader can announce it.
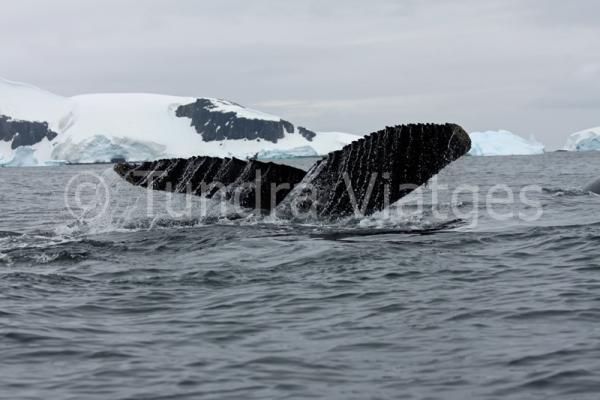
[0,79,359,165]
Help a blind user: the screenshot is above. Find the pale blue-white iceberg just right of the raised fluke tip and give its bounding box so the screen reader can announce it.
[469,130,544,156]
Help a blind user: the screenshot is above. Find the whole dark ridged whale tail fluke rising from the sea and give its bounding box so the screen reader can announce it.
[114,124,471,219]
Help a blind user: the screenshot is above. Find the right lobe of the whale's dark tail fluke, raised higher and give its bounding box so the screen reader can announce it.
[278,124,471,218]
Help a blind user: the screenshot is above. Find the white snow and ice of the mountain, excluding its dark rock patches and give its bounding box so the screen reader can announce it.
[0,76,359,165]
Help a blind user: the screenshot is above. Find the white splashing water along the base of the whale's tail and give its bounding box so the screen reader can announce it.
[54,188,464,237]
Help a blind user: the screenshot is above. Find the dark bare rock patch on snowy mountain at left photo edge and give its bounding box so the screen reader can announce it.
[0,115,58,150]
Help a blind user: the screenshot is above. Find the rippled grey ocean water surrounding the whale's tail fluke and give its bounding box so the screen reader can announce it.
[0,153,600,400]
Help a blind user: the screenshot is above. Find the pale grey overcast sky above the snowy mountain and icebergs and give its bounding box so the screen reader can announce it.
[0,0,600,149]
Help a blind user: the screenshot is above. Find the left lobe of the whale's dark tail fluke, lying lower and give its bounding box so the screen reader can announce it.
[114,157,305,210]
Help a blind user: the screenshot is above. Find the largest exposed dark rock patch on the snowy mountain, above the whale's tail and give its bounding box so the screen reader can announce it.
[175,99,294,143]
